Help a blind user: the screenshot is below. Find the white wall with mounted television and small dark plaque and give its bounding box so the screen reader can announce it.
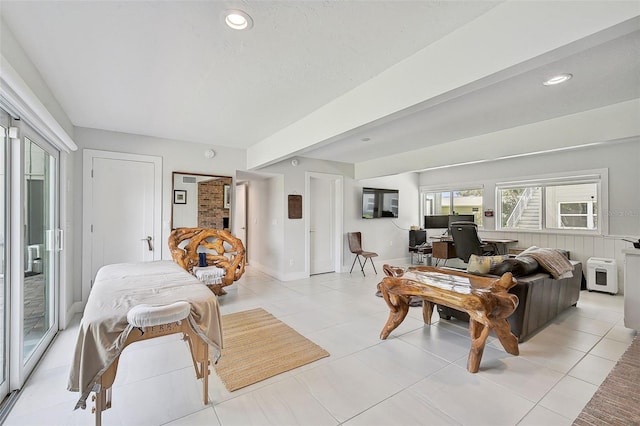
[248,158,419,280]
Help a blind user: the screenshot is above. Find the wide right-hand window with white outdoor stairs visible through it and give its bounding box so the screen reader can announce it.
[496,171,606,232]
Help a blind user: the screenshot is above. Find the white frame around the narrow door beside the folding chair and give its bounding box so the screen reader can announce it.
[303,172,344,276]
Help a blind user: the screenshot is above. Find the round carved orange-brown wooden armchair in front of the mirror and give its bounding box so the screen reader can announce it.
[169,228,245,296]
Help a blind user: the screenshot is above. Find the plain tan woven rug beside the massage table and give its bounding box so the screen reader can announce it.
[215,308,329,392]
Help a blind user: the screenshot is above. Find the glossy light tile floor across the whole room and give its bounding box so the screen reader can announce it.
[6,268,635,426]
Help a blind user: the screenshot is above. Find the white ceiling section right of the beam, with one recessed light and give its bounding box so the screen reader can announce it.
[303,27,640,163]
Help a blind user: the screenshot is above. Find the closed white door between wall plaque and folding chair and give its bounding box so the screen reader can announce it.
[309,177,335,275]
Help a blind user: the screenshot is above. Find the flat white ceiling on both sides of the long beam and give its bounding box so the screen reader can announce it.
[0,0,640,171]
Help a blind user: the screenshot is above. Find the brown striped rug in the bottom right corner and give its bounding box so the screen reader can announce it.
[573,336,640,426]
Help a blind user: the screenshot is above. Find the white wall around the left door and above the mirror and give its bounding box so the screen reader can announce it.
[70,127,245,301]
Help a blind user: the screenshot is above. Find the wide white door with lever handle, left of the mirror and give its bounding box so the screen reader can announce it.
[83,150,162,301]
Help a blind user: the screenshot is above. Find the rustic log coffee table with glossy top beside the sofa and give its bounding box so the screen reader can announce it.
[378,265,519,373]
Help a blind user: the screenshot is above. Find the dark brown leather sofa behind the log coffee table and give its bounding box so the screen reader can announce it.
[438,261,583,342]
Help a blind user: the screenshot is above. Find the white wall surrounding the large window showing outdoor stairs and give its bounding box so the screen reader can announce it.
[420,139,640,292]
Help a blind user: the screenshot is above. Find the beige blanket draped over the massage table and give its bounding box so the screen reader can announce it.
[67,261,222,408]
